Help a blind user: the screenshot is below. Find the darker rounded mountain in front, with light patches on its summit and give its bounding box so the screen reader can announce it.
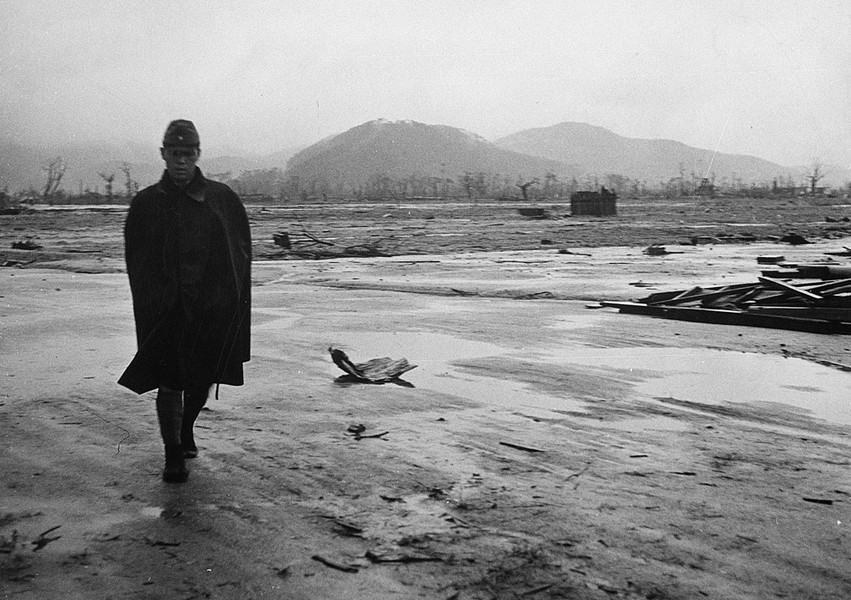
[286,119,565,188]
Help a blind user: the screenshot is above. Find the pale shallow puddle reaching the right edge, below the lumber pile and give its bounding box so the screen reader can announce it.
[554,348,851,425]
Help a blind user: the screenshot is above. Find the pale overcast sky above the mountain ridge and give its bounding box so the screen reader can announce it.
[0,0,851,166]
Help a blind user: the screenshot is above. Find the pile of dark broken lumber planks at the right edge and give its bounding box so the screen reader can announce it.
[601,277,851,334]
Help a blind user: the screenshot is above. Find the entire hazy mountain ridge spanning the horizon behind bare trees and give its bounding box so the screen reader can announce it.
[0,119,851,193]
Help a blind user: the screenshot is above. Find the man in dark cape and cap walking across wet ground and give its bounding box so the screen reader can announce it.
[118,119,251,482]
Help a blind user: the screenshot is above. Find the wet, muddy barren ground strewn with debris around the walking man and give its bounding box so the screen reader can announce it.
[0,199,851,600]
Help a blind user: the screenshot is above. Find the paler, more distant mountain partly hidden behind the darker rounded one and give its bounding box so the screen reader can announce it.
[494,122,800,185]
